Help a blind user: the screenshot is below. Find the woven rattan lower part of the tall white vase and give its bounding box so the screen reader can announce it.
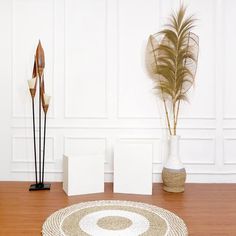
[162,167,186,193]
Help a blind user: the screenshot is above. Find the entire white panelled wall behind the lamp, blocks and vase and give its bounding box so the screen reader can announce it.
[0,0,236,182]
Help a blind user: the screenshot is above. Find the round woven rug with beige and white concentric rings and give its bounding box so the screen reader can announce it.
[42,200,188,236]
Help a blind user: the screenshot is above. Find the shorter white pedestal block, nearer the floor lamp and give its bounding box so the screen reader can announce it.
[63,155,104,196]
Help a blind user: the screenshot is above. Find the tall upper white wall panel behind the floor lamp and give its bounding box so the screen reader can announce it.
[12,0,54,118]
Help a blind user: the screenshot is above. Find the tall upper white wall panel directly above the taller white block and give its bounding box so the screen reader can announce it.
[117,0,158,118]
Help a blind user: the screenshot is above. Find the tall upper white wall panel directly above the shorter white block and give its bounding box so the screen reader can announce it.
[64,0,108,119]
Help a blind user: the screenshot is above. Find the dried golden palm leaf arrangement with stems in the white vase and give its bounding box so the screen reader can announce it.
[146,6,199,135]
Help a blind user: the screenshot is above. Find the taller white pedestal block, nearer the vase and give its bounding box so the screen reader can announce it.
[114,143,153,194]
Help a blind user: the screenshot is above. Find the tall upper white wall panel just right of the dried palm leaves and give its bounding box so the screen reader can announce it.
[177,0,216,119]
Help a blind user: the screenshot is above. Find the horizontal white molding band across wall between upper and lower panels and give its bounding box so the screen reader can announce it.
[12,118,216,130]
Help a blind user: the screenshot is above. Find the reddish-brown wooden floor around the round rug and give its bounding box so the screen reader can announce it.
[0,182,236,236]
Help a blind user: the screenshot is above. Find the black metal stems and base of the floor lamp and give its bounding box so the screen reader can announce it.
[29,73,51,191]
